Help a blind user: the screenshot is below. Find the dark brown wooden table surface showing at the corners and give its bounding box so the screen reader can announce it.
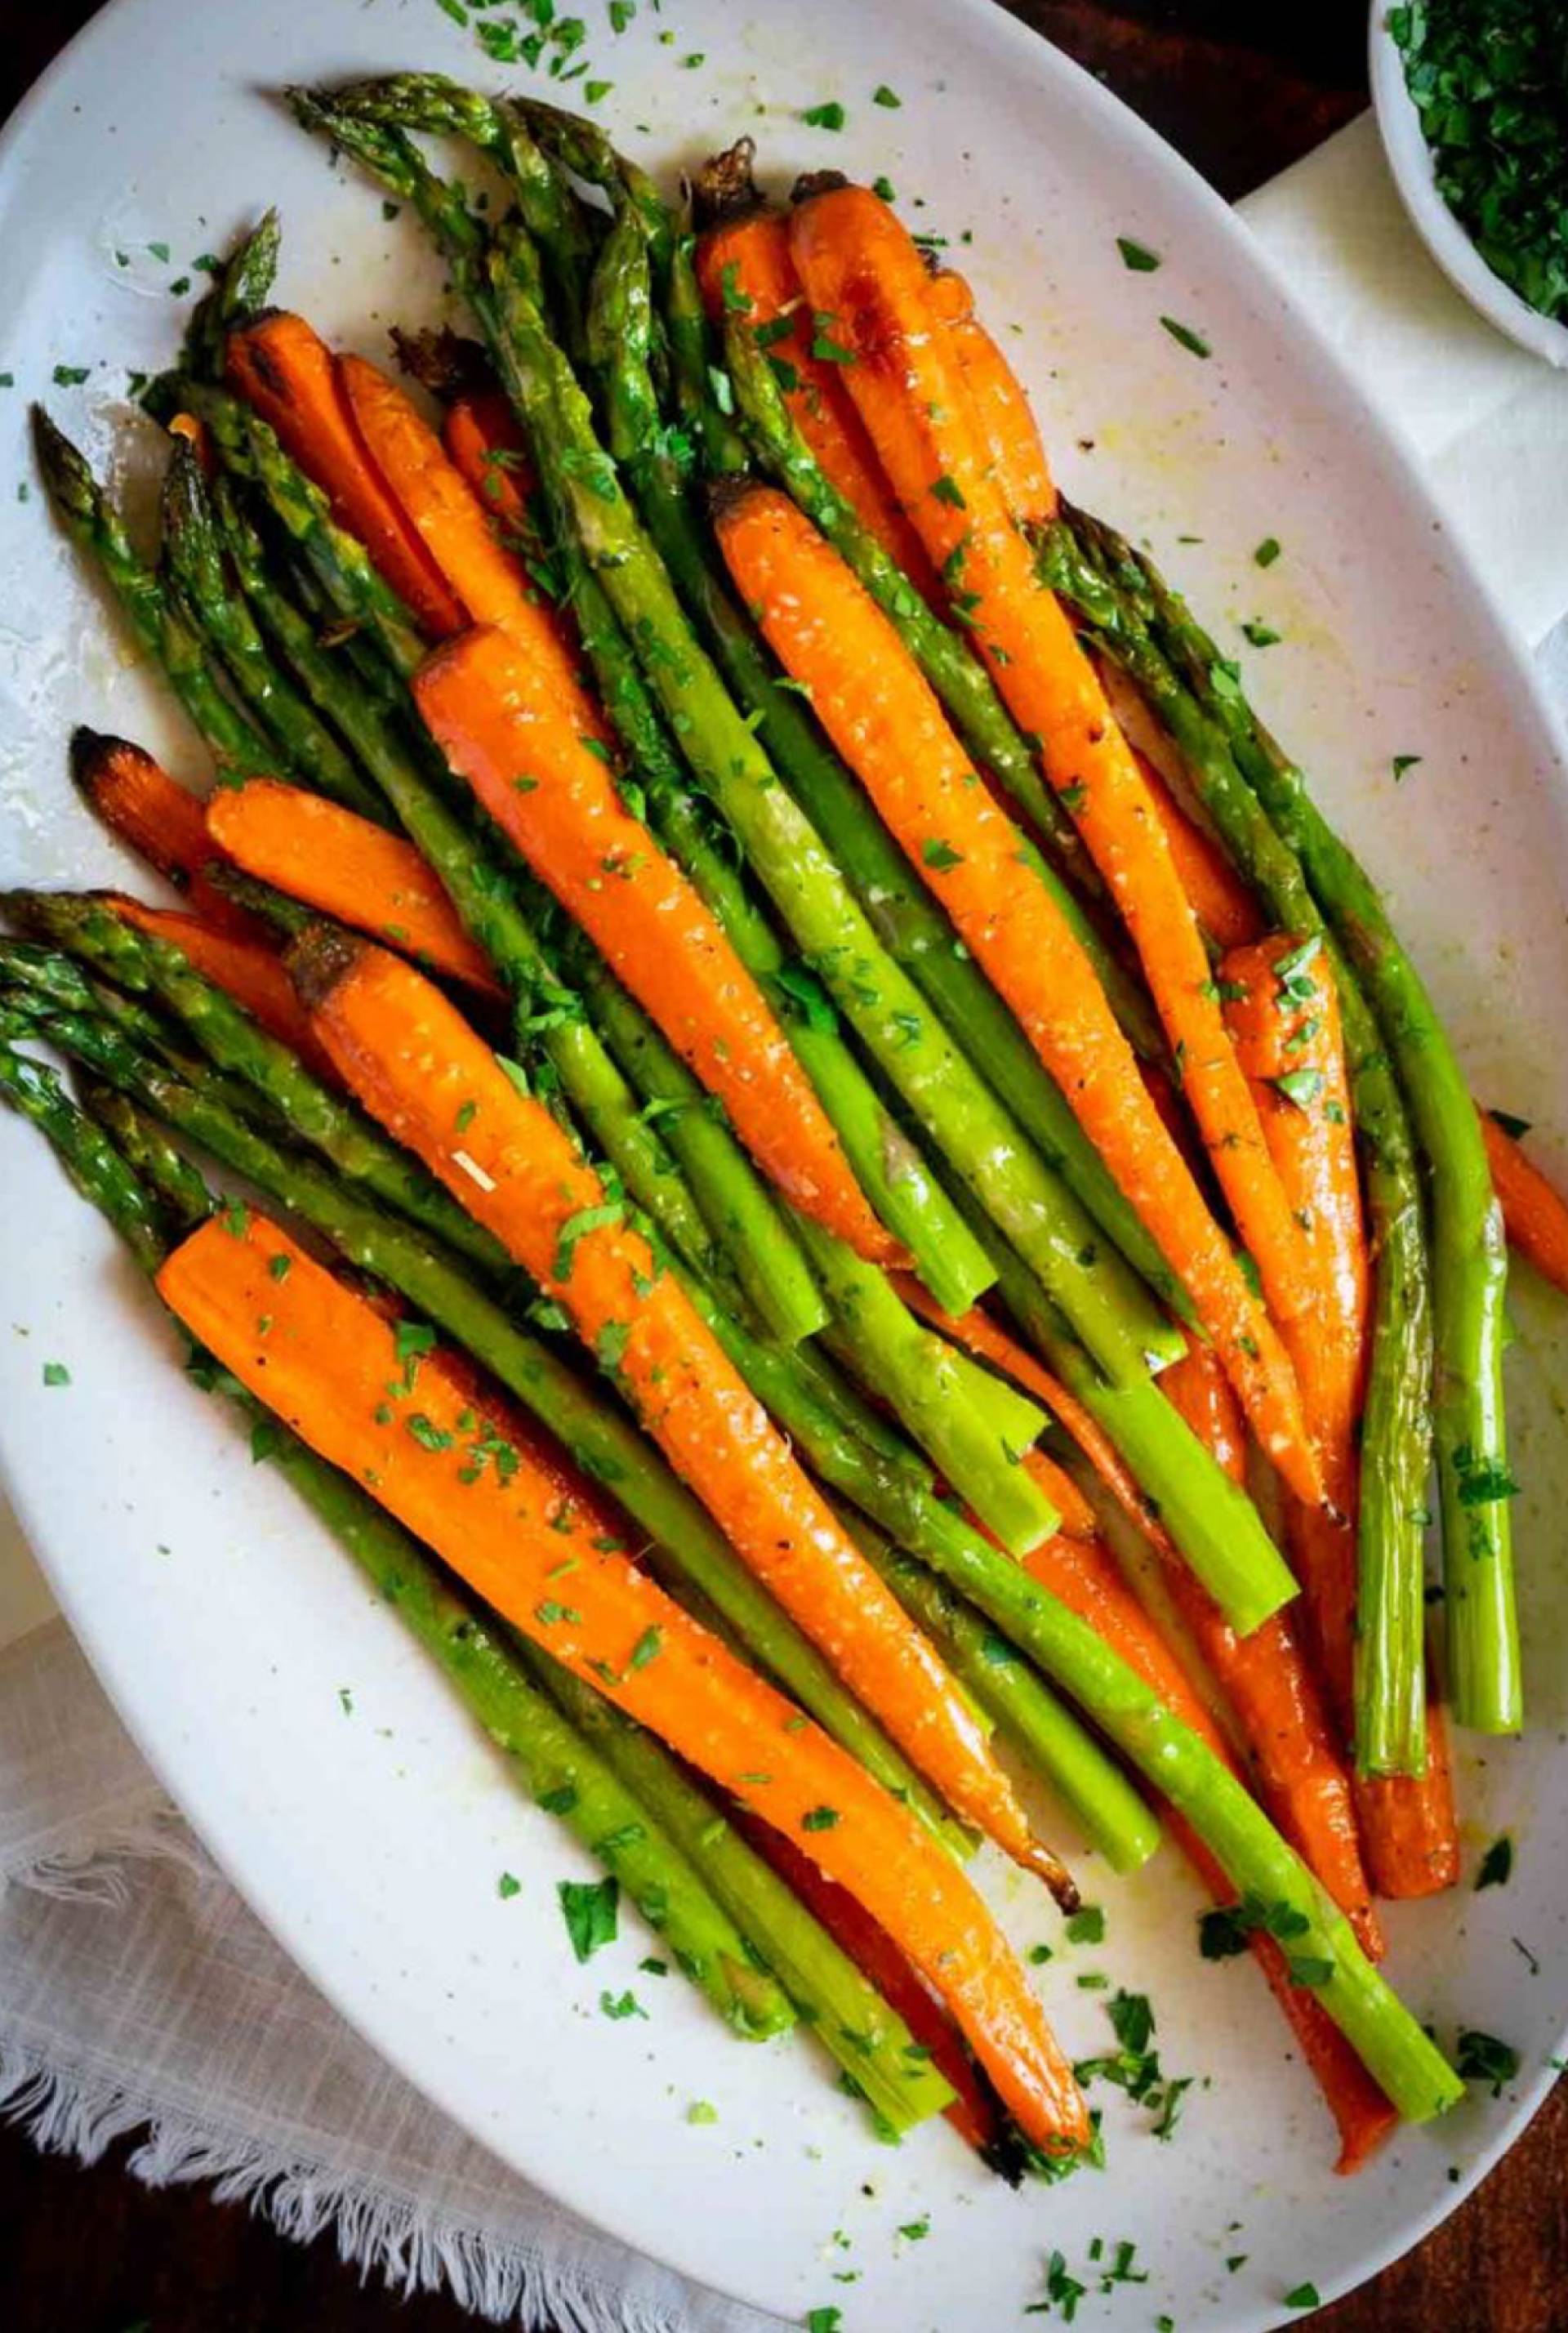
[0,0,1568,2333]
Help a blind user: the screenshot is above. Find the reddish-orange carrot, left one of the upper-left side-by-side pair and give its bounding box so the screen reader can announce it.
[224,308,462,640]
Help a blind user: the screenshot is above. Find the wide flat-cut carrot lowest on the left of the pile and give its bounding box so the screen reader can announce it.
[158,1213,1089,2151]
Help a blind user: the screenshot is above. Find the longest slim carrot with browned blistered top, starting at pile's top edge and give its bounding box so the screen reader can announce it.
[791,186,1323,1502]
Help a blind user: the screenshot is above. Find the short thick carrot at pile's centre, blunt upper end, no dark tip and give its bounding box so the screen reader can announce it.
[416,630,896,1262]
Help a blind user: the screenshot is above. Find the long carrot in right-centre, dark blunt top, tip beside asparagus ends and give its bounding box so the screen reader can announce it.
[716,478,1318,1498]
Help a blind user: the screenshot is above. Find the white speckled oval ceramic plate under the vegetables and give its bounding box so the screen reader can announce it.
[0,0,1568,2333]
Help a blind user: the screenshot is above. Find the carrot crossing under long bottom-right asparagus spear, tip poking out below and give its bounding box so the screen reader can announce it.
[1029,1535,1397,2172]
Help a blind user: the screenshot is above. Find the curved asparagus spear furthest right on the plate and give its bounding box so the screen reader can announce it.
[1071,513,1524,1733]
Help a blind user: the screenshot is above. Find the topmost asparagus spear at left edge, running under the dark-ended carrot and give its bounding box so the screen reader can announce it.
[0,891,514,1278]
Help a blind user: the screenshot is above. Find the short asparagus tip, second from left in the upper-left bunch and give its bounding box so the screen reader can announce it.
[163,436,385,826]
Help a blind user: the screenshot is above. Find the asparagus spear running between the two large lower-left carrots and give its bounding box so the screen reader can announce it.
[9,1013,969,1853]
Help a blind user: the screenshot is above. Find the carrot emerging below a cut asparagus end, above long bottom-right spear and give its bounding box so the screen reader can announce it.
[1160,1346,1383,1960]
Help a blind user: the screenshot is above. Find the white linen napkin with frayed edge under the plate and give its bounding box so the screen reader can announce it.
[0,114,1568,2333]
